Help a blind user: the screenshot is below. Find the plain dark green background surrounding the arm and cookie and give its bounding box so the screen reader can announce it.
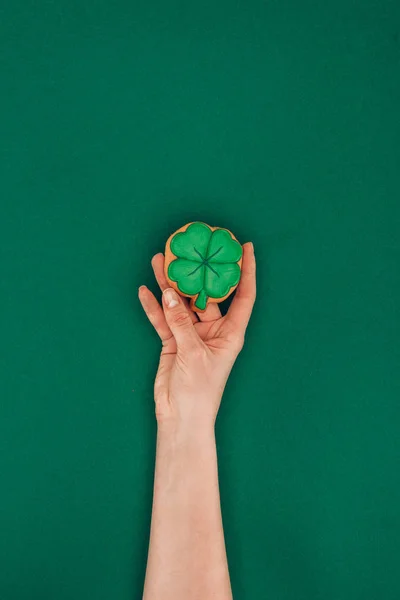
[0,0,400,600]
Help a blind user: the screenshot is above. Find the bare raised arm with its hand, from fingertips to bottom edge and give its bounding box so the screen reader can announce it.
[139,243,256,600]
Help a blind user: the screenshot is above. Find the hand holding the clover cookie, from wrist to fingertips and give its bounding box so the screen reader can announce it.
[139,243,256,432]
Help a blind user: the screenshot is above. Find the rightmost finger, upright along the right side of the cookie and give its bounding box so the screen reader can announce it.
[227,242,256,335]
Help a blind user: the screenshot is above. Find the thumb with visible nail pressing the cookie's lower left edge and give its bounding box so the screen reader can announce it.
[162,288,199,350]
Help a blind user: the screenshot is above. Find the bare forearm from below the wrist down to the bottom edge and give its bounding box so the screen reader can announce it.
[144,428,232,600]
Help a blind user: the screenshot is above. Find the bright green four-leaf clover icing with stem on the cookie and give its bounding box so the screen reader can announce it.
[168,223,242,310]
